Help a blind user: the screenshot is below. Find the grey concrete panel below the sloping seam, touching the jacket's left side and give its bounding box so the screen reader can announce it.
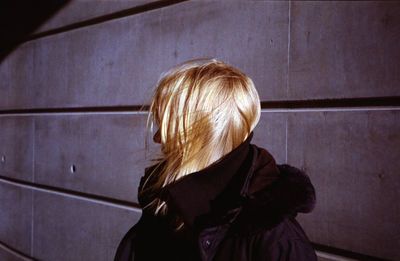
[33,191,141,261]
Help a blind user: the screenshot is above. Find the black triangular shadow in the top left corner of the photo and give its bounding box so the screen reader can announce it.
[0,0,71,62]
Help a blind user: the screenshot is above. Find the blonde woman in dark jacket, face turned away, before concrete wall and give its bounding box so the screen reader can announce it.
[115,59,316,261]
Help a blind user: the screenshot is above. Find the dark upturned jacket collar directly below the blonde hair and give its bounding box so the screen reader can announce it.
[167,133,279,229]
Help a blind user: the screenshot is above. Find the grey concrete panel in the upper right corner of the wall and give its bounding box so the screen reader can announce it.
[289,1,400,99]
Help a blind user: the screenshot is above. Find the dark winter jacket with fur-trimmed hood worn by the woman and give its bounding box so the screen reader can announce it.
[115,135,317,261]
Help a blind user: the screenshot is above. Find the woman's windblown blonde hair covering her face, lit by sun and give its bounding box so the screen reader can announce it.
[140,59,260,223]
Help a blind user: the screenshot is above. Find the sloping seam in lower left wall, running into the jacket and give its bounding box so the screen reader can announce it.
[0,176,141,213]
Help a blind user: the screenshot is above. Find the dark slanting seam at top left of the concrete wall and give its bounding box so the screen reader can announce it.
[21,0,188,43]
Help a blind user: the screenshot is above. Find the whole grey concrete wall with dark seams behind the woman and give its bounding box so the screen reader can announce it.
[0,1,400,260]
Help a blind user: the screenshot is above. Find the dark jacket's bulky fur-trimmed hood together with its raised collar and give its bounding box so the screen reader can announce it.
[167,133,315,231]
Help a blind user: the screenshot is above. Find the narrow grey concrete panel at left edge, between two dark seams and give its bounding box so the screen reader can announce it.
[0,116,34,181]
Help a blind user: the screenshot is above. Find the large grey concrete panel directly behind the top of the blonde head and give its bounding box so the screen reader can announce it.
[0,1,289,109]
